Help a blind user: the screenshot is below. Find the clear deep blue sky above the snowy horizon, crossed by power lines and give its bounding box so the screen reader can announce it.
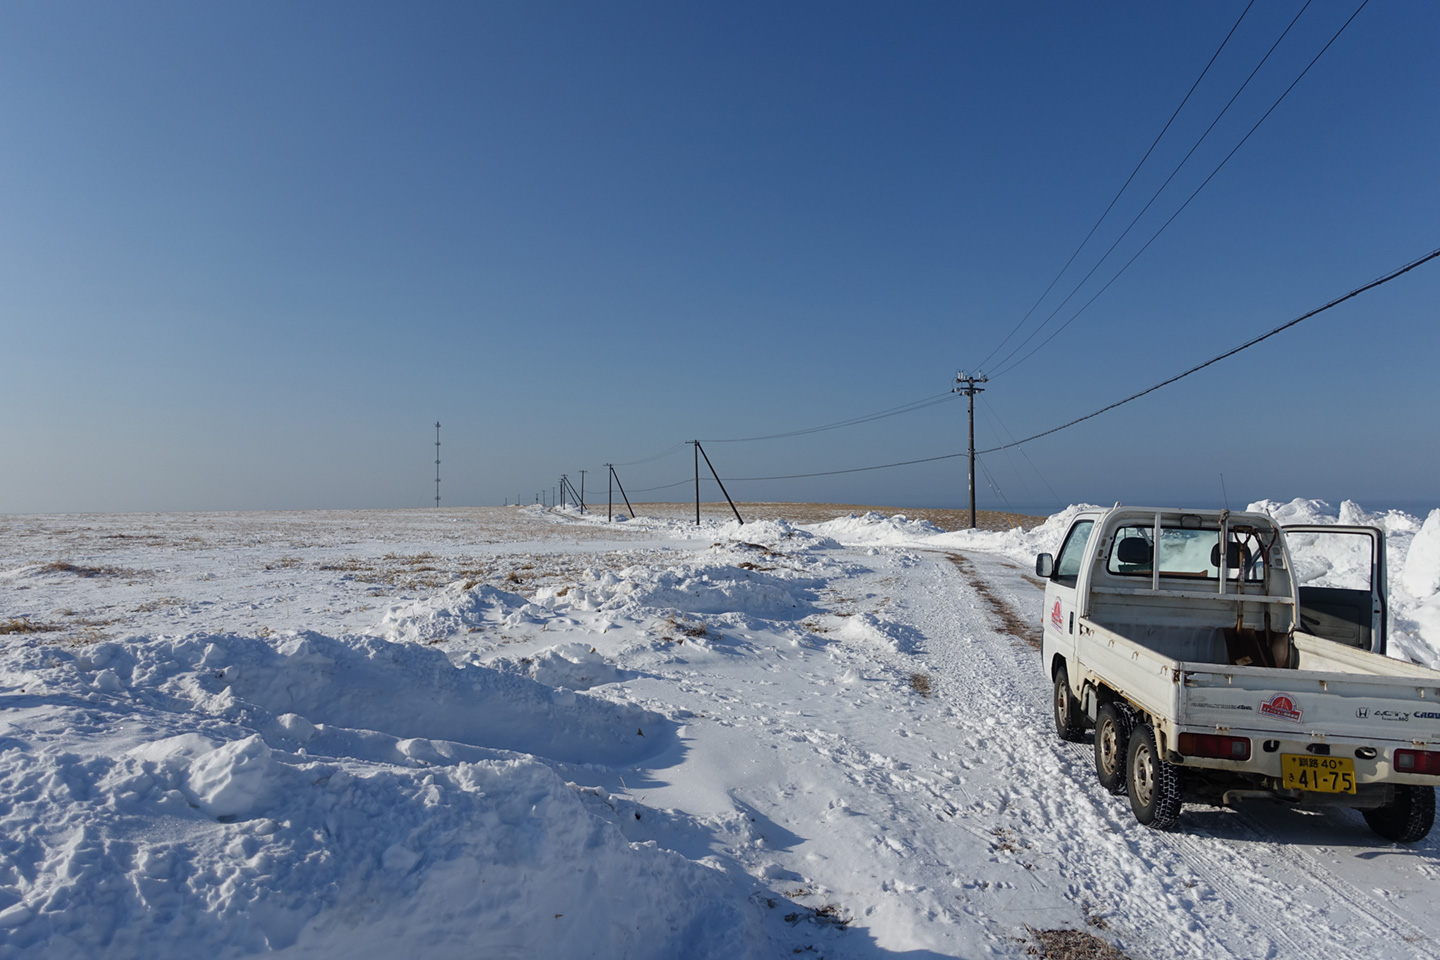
[0,0,1440,512]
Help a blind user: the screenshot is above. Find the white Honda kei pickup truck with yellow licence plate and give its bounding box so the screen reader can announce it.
[1035,504,1440,843]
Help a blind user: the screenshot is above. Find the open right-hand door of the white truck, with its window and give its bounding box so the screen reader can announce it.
[1283,524,1387,653]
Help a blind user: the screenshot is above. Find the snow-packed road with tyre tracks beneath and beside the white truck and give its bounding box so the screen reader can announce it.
[887,554,1440,959]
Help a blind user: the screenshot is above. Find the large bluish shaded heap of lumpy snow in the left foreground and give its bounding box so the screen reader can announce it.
[0,633,757,959]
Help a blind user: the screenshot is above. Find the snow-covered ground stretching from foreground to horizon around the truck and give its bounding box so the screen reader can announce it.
[0,501,1440,960]
